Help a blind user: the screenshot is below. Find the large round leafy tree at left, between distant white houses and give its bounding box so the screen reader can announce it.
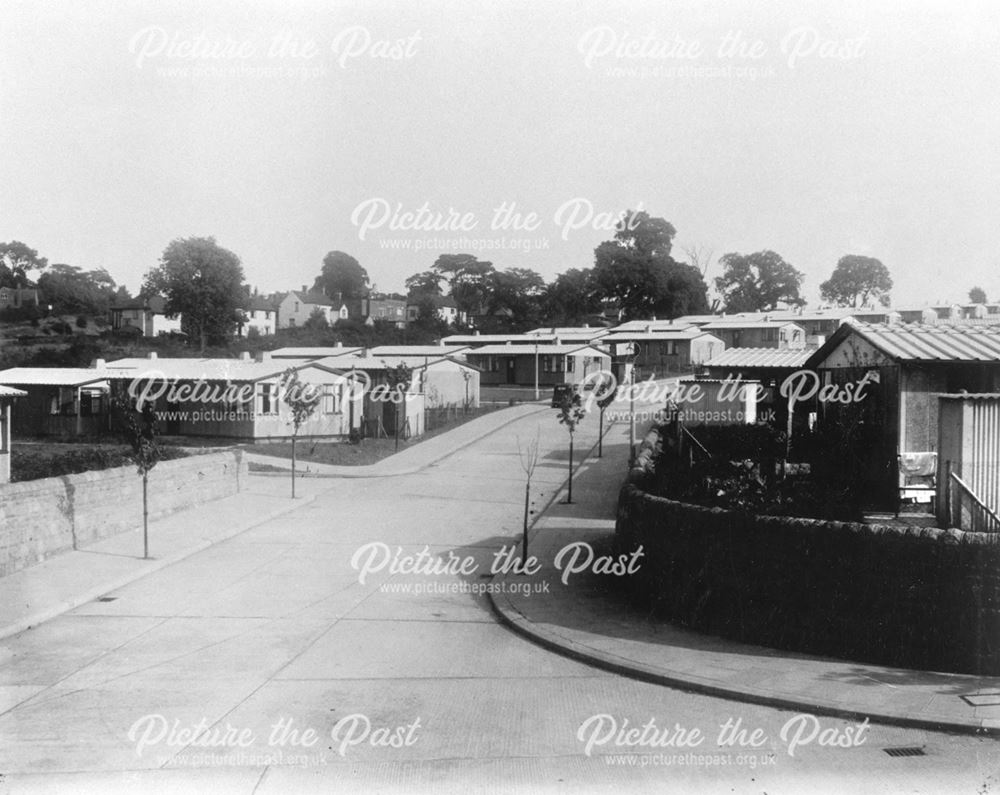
[143,237,246,353]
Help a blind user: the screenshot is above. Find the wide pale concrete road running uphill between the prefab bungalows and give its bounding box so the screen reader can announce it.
[0,394,1000,793]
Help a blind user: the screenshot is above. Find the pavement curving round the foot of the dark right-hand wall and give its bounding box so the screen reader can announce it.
[491,432,1000,734]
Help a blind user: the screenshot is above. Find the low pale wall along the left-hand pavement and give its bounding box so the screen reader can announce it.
[0,450,247,576]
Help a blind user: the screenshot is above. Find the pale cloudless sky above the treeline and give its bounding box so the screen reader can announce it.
[0,0,1000,305]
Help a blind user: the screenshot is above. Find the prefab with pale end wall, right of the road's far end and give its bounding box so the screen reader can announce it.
[600,326,726,380]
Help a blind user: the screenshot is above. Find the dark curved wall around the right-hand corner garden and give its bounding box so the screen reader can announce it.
[616,431,1000,675]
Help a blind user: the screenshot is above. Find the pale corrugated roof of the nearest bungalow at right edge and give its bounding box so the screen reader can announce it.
[836,323,1000,362]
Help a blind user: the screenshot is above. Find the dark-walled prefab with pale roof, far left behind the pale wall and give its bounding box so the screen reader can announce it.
[0,366,108,438]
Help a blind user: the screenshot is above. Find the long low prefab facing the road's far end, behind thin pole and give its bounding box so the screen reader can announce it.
[465,344,611,386]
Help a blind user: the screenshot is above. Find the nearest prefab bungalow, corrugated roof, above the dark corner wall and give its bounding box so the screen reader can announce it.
[805,323,1000,510]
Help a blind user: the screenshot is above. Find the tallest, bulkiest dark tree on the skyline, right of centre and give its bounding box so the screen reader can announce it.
[592,212,708,320]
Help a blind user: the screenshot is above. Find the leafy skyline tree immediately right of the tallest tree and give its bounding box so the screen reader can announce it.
[715,250,805,312]
